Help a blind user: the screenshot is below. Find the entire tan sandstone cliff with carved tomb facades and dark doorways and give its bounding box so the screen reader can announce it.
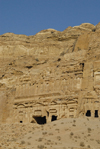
[0,23,100,124]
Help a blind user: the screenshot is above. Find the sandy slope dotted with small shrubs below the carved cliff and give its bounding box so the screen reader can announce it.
[0,118,100,149]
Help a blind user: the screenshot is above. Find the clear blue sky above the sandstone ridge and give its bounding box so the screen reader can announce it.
[0,0,100,35]
